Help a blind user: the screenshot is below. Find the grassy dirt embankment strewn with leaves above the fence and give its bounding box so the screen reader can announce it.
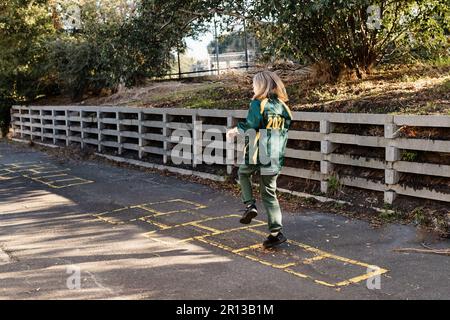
[37,61,450,114]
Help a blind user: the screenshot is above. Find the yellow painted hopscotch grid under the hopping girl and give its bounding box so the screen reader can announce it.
[94,199,388,287]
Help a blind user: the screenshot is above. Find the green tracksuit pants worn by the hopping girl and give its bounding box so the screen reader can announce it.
[238,164,283,232]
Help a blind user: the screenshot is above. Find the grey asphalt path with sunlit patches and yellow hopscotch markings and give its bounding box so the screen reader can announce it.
[0,142,450,299]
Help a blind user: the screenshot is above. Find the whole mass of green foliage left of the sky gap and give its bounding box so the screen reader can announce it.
[0,0,232,102]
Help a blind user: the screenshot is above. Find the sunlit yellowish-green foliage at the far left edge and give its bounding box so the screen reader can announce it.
[0,0,53,101]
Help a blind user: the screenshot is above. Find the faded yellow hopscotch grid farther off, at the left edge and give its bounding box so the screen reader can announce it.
[0,162,94,189]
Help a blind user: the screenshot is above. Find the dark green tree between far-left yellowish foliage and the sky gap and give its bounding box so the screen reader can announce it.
[49,0,232,100]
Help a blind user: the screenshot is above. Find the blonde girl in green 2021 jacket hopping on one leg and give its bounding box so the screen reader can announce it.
[227,71,292,248]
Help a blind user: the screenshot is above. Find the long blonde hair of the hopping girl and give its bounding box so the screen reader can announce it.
[253,70,289,102]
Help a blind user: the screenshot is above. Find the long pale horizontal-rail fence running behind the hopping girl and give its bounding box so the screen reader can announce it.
[11,106,450,204]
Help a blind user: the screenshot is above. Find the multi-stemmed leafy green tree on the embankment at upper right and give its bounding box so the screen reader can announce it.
[248,0,450,77]
